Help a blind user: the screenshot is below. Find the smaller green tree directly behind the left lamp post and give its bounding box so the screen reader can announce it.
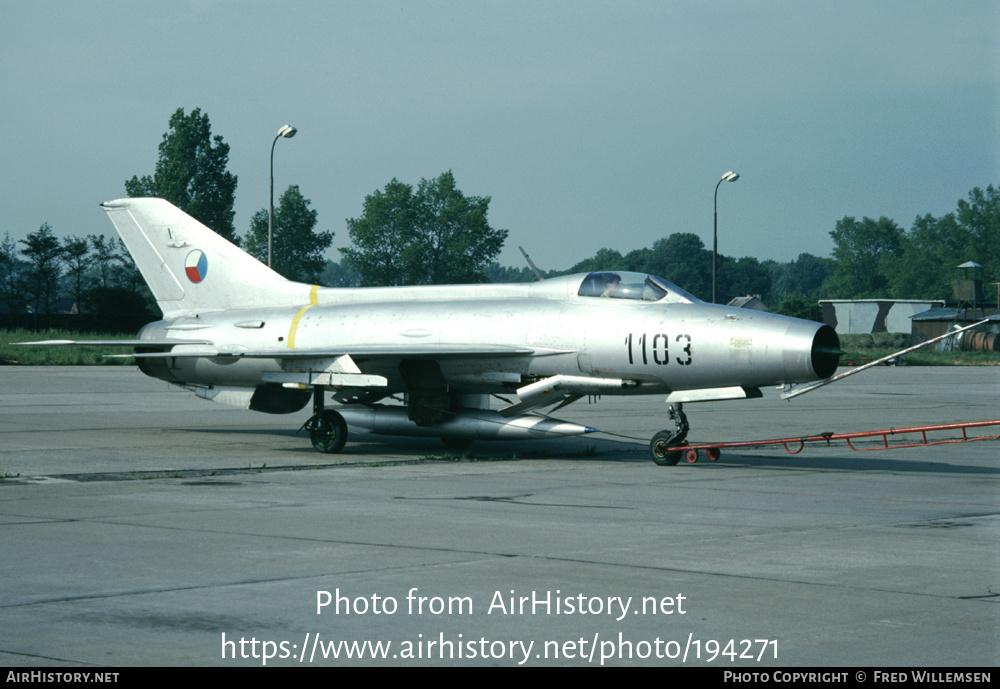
[245,184,333,283]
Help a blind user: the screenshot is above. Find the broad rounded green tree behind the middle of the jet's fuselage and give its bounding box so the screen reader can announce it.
[341,171,507,285]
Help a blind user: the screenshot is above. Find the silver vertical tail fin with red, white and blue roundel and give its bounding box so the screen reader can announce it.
[101,198,309,318]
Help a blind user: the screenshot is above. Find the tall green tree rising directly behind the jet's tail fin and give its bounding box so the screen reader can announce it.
[125,108,239,244]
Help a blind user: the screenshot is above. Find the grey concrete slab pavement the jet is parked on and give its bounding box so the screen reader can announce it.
[0,367,1000,671]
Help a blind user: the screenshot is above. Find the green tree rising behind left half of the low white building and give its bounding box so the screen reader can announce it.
[823,217,903,299]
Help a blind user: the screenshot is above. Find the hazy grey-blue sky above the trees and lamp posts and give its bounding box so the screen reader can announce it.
[0,0,1000,269]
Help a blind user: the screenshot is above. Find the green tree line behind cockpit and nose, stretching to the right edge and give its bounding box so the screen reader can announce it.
[480,185,1000,320]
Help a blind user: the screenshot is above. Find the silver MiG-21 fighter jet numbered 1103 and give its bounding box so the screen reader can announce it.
[29,198,842,464]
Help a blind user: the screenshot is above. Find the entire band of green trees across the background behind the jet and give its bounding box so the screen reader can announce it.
[0,108,1000,331]
